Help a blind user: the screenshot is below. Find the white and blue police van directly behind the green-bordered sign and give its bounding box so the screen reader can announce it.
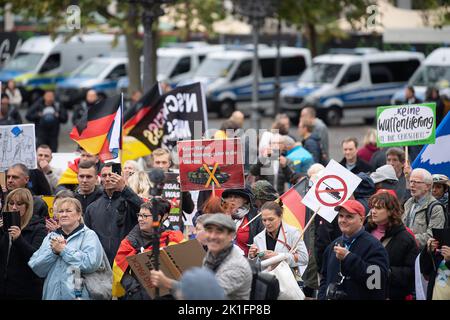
[281,51,424,125]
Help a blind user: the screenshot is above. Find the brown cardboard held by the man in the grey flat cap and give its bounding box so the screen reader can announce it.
[127,240,206,298]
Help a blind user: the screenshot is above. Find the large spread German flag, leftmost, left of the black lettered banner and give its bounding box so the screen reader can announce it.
[70,95,121,160]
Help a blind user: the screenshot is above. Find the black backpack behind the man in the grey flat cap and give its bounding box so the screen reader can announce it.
[248,260,280,300]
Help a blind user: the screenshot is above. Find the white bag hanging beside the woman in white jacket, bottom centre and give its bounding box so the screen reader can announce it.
[268,261,305,300]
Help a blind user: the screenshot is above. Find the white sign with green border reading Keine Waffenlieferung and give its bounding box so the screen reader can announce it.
[377,103,436,147]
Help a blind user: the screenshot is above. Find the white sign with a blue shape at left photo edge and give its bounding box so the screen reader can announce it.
[0,124,37,171]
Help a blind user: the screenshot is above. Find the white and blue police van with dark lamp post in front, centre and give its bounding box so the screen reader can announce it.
[185,46,311,117]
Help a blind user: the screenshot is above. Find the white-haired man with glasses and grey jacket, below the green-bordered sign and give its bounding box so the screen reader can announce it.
[403,168,445,250]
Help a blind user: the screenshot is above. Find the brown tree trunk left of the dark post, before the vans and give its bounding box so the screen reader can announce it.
[125,6,142,96]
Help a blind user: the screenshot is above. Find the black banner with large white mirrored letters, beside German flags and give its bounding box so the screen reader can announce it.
[128,83,208,151]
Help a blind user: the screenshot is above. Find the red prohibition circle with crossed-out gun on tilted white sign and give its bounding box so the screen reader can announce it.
[315,175,348,207]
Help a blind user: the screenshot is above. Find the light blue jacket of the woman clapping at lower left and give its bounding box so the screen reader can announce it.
[28,226,103,300]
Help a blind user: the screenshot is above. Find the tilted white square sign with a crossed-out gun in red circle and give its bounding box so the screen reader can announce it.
[302,160,361,223]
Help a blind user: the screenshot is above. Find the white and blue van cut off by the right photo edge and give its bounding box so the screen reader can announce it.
[391,48,450,104]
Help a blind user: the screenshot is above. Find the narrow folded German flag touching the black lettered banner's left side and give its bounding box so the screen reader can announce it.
[123,82,161,135]
